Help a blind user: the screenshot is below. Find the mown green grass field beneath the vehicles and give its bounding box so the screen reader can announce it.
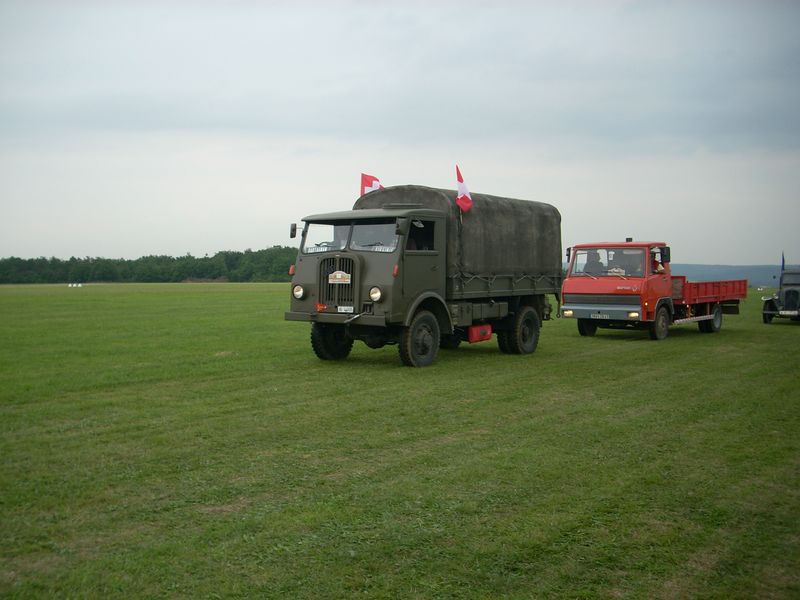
[0,284,800,598]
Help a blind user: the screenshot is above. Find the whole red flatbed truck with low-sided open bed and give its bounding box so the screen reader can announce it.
[560,238,747,340]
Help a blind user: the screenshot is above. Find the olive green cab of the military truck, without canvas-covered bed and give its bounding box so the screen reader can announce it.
[285,207,452,366]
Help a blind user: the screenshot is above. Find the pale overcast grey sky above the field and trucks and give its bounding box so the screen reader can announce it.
[0,0,800,264]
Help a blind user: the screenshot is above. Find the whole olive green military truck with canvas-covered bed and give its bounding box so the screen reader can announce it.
[285,185,562,367]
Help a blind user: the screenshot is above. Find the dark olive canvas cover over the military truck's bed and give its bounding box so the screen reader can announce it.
[353,185,561,278]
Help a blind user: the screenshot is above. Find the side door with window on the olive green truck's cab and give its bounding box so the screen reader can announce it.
[402,217,447,300]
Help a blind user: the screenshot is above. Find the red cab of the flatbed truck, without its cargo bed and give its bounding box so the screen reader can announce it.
[561,241,674,335]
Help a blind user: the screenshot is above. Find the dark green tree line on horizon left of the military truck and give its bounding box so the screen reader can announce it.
[0,246,297,283]
